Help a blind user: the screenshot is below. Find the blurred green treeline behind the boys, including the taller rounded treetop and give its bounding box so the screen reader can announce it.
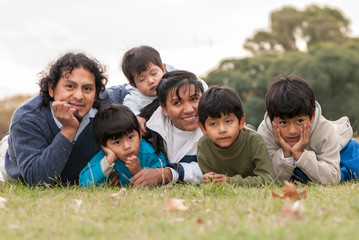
[204,5,359,132]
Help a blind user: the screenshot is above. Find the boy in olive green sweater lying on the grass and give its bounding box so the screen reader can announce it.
[197,86,274,186]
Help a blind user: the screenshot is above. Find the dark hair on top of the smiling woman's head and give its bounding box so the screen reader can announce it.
[157,70,203,106]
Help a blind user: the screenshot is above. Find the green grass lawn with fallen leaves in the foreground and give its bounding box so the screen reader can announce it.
[0,183,359,240]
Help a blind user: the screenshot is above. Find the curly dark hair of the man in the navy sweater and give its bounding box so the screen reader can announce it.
[39,52,108,108]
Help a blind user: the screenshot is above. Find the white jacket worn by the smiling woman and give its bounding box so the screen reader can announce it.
[146,107,203,184]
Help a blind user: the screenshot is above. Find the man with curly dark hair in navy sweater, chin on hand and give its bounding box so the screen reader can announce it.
[1,52,128,186]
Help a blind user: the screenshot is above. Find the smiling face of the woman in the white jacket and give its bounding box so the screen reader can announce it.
[161,84,202,131]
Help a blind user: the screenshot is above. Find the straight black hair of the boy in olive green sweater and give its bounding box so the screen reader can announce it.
[198,86,243,128]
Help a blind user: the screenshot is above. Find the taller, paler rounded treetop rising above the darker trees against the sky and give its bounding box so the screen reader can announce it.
[243,5,350,56]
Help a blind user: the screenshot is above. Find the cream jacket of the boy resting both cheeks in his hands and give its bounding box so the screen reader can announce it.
[258,102,353,185]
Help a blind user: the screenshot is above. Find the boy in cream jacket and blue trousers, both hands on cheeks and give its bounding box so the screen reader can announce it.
[258,74,359,185]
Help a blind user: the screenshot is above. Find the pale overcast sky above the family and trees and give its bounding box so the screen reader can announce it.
[0,0,359,99]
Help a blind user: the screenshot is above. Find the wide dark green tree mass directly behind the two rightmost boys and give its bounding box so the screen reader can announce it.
[205,39,359,131]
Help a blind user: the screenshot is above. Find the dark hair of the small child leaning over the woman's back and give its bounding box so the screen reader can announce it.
[121,45,164,87]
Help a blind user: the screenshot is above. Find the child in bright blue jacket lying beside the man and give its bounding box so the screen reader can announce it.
[79,104,166,187]
